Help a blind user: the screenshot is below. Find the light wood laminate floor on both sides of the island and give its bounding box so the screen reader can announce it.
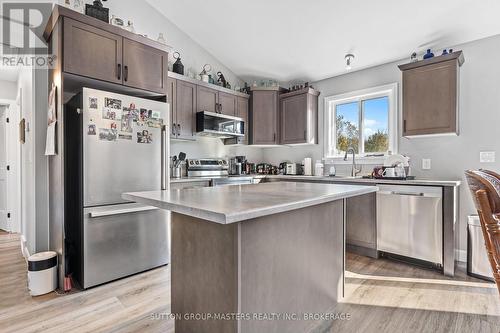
[0,233,500,333]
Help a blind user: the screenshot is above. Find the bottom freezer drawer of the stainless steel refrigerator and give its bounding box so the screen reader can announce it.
[82,203,170,288]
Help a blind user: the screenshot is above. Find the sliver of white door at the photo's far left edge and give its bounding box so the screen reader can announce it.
[0,106,8,231]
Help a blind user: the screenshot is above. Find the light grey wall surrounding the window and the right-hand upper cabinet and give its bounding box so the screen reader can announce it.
[264,35,500,251]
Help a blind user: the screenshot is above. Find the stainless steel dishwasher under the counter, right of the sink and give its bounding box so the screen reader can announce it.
[377,185,443,267]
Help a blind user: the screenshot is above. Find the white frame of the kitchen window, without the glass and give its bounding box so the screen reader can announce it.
[323,82,399,164]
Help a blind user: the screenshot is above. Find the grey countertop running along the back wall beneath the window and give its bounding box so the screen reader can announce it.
[170,175,461,187]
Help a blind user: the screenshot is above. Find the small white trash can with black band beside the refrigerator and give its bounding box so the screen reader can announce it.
[28,251,57,296]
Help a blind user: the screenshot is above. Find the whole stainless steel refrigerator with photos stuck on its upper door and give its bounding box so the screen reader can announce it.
[64,88,170,288]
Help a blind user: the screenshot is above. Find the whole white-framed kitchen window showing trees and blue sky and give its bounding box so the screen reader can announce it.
[324,83,397,163]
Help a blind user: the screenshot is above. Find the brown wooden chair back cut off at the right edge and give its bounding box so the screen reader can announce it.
[465,170,500,293]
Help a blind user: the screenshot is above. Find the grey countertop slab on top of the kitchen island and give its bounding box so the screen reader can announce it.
[122,182,378,224]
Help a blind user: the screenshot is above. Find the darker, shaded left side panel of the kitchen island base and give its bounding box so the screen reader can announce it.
[171,213,238,333]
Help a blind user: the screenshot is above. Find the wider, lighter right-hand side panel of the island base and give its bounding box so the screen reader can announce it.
[239,200,344,333]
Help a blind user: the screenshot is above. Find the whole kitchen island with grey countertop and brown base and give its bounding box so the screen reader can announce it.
[123,182,377,333]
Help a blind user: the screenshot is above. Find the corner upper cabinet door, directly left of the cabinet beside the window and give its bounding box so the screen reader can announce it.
[249,89,279,145]
